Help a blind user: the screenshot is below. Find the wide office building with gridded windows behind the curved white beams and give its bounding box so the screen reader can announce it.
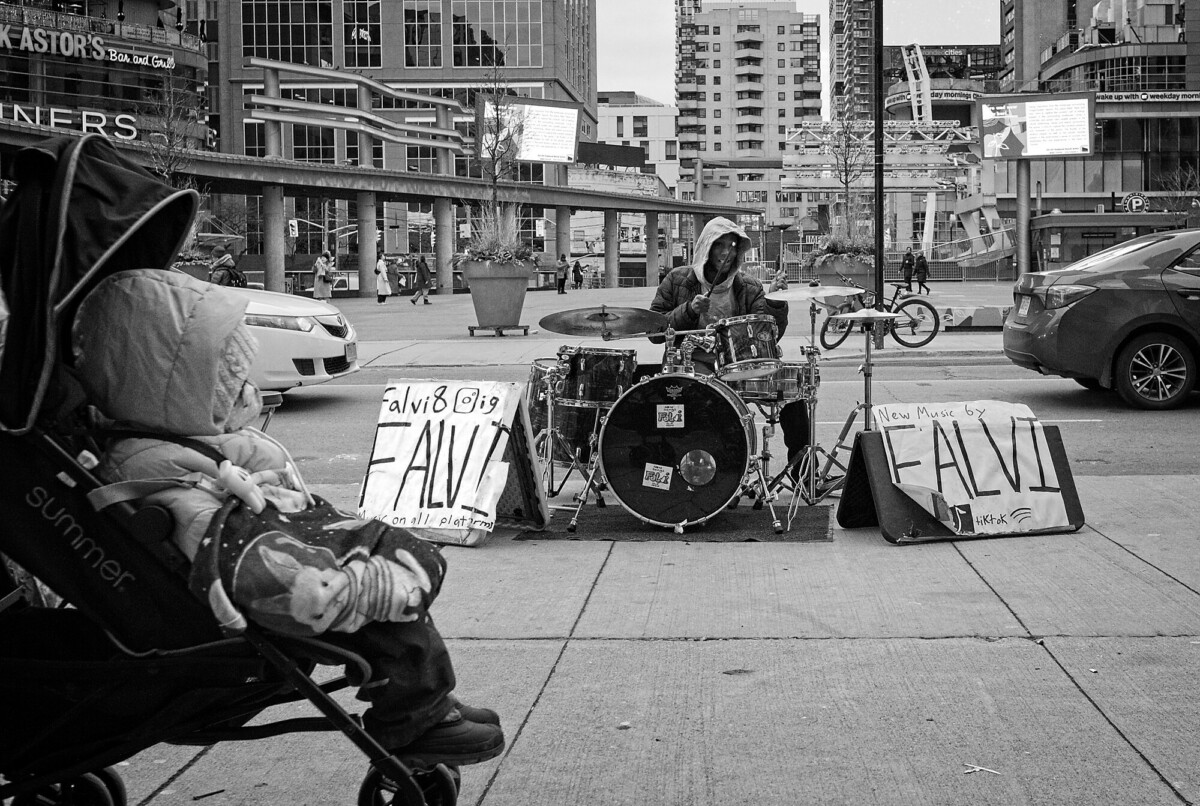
[215,0,598,253]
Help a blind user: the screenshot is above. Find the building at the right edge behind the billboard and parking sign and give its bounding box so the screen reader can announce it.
[985,0,1200,223]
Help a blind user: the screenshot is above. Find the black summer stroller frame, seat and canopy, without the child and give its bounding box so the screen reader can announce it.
[0,136,460,806]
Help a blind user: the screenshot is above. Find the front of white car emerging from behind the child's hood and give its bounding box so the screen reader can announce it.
[229,288,359,391]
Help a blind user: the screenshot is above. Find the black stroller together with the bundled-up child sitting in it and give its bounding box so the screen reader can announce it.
[0,136,504,804]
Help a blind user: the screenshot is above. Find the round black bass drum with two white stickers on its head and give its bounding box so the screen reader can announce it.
[600,374,755,527]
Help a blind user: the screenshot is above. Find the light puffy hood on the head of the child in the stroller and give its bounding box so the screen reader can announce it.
[72,269,262,435]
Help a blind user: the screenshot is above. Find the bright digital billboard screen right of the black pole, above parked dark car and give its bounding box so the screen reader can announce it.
[978,92,1096,160]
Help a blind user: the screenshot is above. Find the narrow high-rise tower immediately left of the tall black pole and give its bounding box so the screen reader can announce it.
[829,0,875,120]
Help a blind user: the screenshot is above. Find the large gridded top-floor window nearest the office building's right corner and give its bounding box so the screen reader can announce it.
[451,0,542,67]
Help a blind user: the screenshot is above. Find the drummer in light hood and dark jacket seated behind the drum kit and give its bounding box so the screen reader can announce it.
[650,216,809,475]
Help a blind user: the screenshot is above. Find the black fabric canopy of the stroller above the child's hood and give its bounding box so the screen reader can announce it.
[0,134,199,433]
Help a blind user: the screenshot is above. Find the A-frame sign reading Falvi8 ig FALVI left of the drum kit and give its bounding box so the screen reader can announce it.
[359,380,548,546]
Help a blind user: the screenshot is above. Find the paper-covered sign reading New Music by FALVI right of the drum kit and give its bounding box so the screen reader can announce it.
[872,401,1074,535]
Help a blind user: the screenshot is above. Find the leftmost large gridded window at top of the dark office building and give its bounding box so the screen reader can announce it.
[241,0,334,67]
